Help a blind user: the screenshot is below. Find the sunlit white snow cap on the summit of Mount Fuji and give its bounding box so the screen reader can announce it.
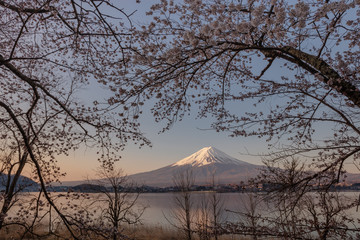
[171,147,249,167]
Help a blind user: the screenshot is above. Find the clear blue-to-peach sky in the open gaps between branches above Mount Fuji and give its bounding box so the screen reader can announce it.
[43,0,360,181]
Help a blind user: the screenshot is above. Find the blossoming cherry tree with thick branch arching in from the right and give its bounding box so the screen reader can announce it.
[124,0,360,189]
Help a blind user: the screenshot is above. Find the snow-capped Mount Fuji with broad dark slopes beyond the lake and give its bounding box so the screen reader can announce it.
[129,147,263,187]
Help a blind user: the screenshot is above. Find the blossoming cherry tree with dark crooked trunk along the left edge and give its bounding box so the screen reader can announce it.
[0,0,149,237]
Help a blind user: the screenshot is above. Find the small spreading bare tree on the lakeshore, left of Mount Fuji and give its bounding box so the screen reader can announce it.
[63,166,146,240]
